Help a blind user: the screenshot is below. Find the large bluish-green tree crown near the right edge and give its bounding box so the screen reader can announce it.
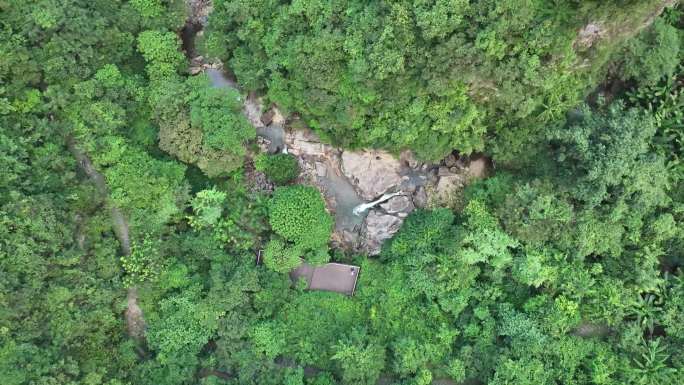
[549,104,666,207]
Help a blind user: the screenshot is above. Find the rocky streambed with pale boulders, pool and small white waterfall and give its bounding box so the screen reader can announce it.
[238,82,490,255]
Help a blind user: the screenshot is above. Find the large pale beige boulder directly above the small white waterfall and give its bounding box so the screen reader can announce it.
[342,151,401,200]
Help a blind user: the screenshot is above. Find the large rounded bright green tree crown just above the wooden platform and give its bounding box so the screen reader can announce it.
[268,186,333,262]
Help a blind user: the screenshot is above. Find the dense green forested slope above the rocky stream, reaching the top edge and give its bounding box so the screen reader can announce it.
[206,0,672,159]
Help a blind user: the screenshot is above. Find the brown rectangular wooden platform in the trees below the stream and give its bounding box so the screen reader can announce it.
[290,262,361,295]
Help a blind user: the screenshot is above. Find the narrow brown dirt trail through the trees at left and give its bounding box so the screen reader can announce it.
[67,138,145,339]
